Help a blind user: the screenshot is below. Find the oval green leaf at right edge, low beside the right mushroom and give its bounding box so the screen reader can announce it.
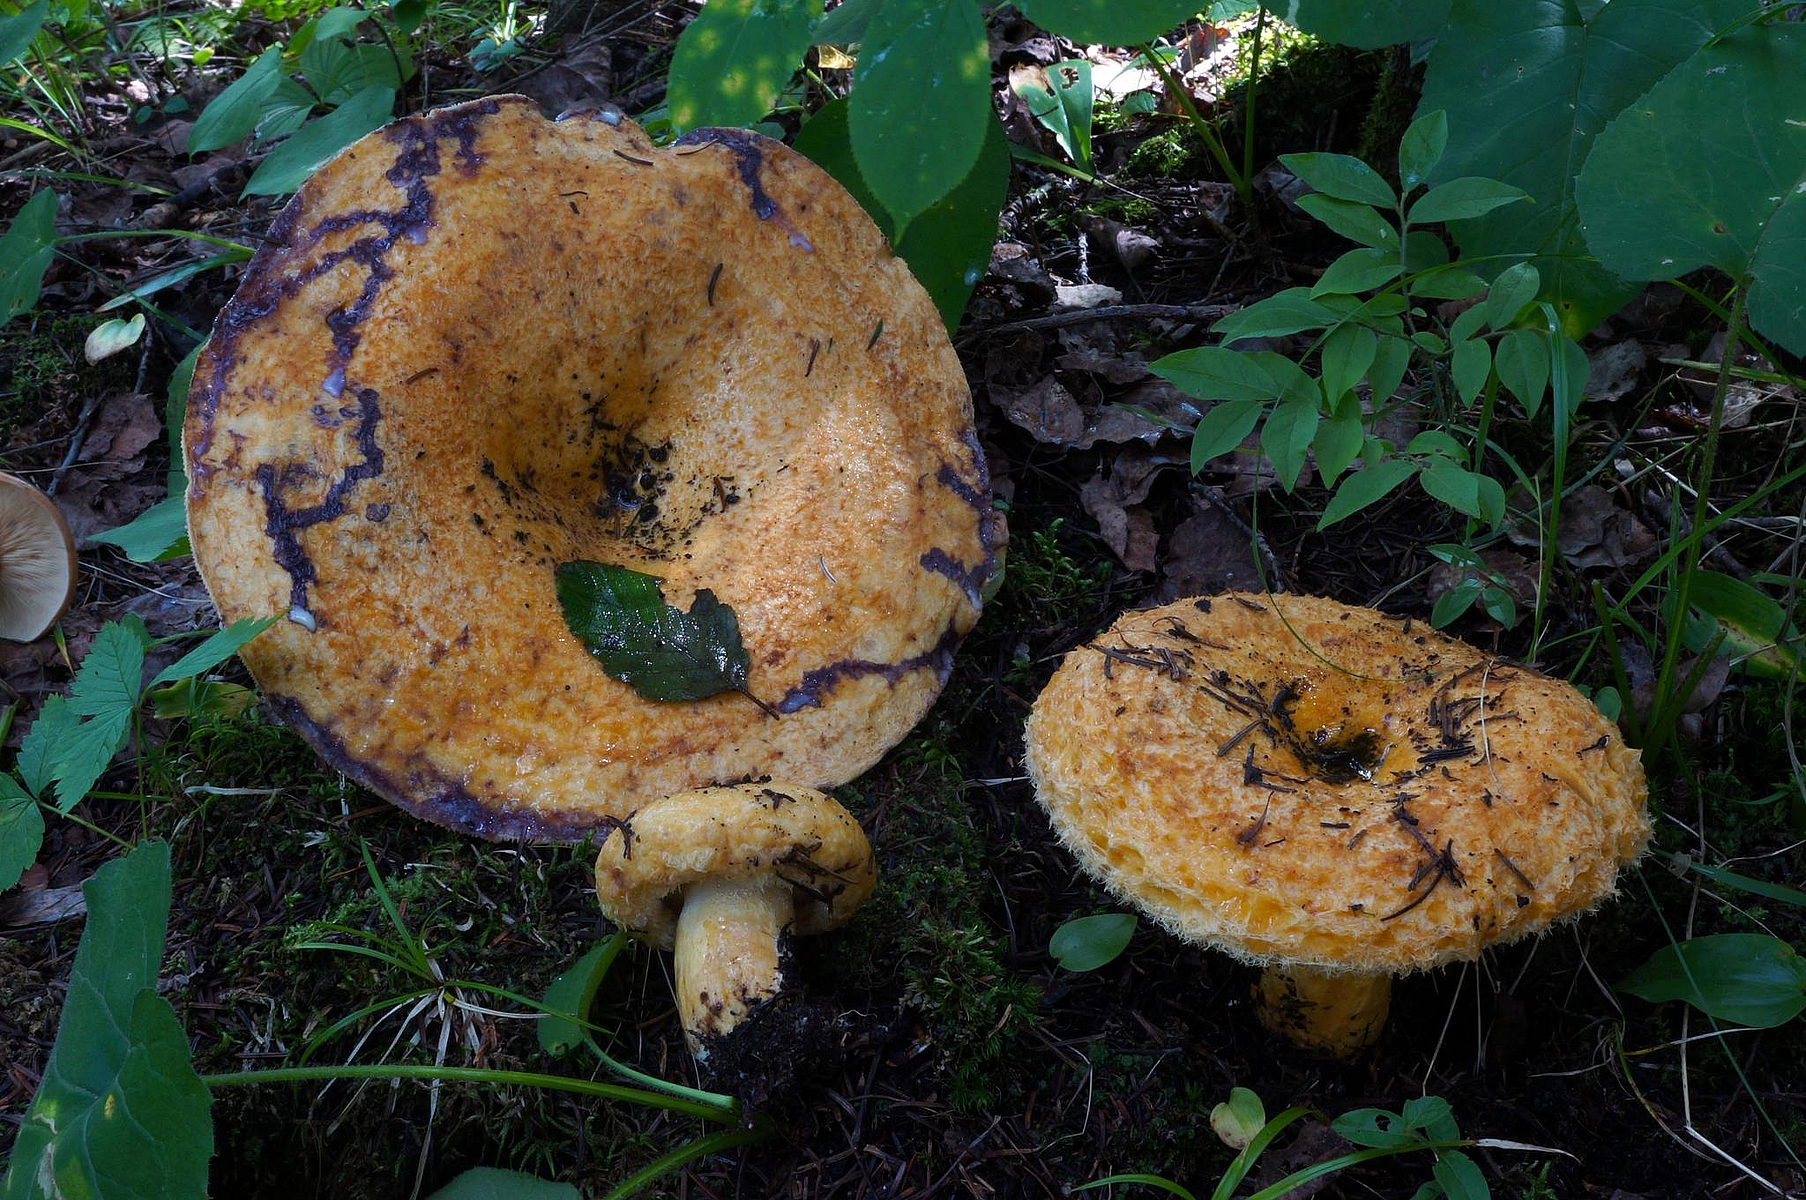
[1618,933,1806,1028]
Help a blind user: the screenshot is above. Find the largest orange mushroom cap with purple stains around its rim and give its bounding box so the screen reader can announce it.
[186,96,999,839]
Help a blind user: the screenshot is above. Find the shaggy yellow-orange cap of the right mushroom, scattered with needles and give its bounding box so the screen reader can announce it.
[1028,595,1649,972]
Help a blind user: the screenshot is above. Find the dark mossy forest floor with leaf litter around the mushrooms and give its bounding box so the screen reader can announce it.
[0,9,1806,1200]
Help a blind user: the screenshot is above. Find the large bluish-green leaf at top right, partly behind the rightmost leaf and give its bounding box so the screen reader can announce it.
[1418,0,1750,336]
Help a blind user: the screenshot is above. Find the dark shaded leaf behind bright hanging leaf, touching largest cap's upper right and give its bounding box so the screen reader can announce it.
[796,98,1010,333]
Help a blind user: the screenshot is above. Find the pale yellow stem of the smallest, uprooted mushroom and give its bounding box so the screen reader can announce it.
[672,875,796,1057]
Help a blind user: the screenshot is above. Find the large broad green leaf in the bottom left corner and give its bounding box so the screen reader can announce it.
[0,842,213,1200]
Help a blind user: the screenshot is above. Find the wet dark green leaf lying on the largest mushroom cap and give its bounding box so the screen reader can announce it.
[556,558,749,699]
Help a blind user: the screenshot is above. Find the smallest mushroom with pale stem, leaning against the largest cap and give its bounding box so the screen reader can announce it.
[596,783,876,1059]
